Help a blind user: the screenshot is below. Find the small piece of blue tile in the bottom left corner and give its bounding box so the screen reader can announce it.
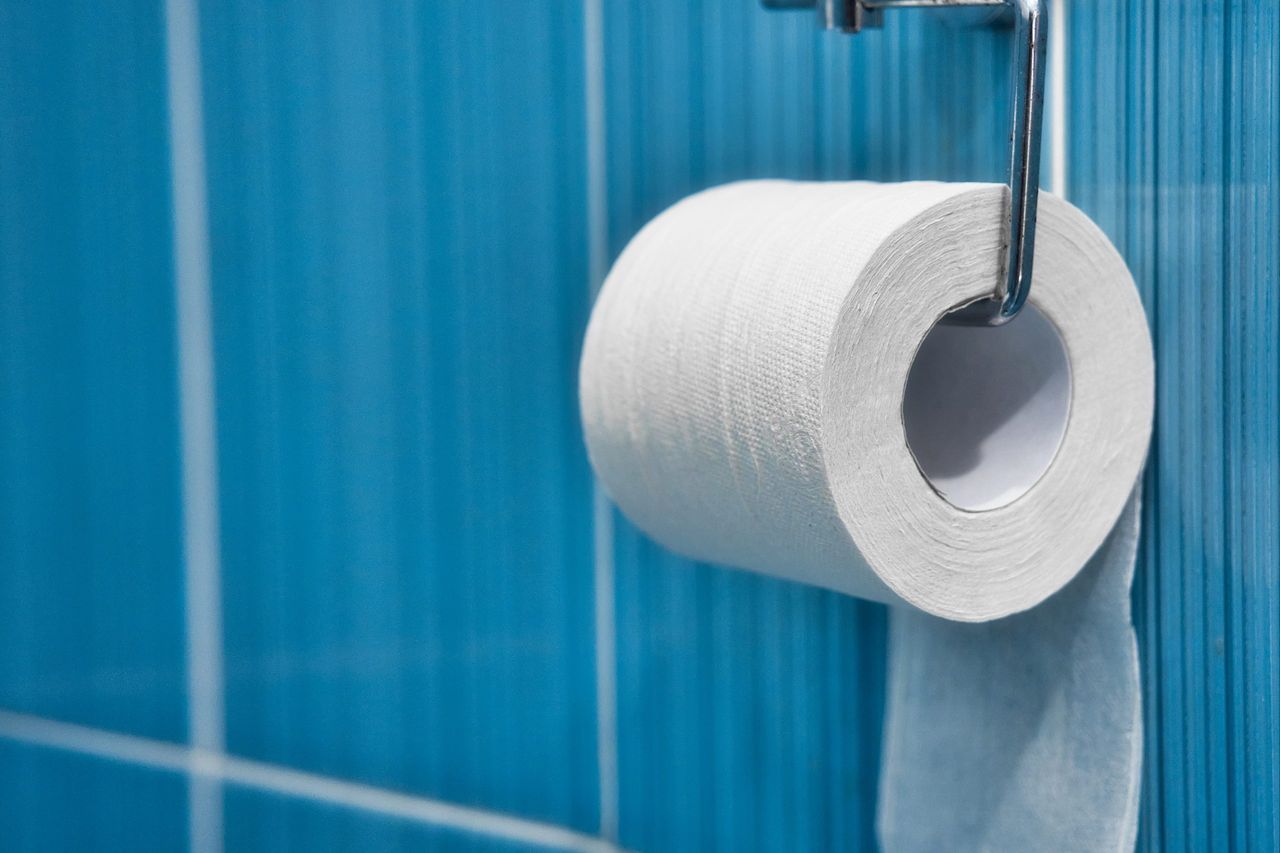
[0,739,187,853]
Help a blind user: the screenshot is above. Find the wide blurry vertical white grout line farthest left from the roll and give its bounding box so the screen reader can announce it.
[165,0,224,853]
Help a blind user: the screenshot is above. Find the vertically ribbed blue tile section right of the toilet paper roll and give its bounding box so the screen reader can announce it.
[1069,0,1280,850]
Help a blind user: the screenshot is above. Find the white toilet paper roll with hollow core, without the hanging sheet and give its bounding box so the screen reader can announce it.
[581,181,1153,621]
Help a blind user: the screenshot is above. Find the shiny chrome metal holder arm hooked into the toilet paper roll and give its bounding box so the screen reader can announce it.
[762,0,1048,325]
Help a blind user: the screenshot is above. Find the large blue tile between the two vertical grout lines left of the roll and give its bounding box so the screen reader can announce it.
[201,0,598,830]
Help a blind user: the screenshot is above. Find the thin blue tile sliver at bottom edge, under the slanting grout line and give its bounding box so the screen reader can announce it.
[223,786,556,853]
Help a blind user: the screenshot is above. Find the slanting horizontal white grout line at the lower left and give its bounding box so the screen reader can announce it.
[0,711,618,853]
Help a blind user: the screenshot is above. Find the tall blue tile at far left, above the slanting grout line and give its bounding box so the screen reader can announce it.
[0,1,186,739]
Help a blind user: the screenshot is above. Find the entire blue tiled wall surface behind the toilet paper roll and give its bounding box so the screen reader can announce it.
[0,0,1280,853]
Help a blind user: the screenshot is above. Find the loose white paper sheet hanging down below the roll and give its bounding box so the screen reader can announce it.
[879,491,1142,853]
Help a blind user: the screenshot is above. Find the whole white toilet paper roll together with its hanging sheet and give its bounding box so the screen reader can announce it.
[580,181,1153,850]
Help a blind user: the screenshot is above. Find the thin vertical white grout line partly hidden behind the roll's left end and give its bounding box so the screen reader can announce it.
[582,0,618,841]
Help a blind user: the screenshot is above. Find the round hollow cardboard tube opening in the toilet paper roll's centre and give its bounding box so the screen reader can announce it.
[902,305,1071,512]
